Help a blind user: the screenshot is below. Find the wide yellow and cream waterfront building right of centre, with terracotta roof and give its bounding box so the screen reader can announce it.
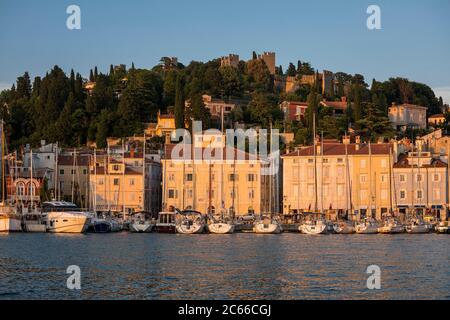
[282,140,393,219]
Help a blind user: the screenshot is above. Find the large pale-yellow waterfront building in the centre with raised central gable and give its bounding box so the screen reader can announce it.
[161,140,270,215]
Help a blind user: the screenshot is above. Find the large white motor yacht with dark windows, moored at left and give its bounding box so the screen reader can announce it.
[42,201,91,233]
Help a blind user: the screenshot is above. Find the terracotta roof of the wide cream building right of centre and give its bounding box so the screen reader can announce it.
[282,143,390,158]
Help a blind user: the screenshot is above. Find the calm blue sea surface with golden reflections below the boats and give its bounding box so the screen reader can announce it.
[0,233,450,299]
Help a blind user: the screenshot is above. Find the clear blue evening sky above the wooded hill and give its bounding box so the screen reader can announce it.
[0,0,450,103]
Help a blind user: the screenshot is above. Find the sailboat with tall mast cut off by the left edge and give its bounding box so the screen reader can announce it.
[0,120,22,232]
